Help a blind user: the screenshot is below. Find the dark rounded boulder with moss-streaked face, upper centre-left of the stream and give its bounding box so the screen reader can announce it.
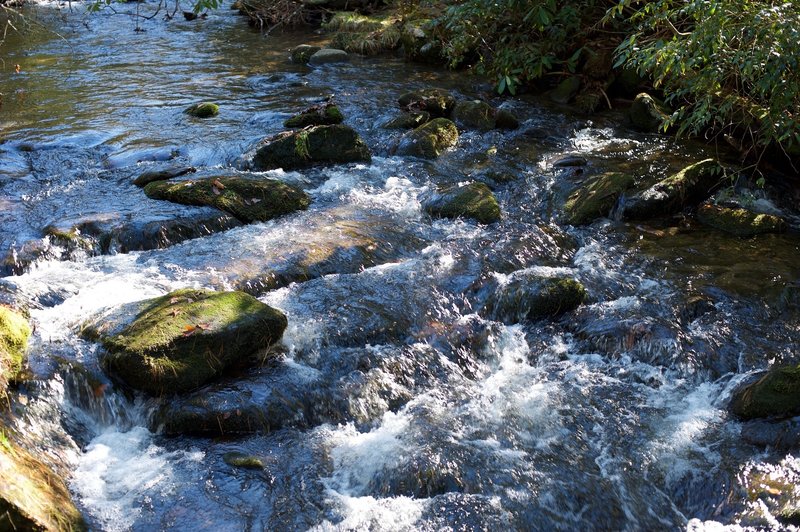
[251,124,371,170]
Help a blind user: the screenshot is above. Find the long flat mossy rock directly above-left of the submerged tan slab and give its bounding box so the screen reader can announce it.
[144,177,311,223]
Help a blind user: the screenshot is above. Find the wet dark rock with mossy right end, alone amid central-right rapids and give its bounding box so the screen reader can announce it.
[480,272,586,324]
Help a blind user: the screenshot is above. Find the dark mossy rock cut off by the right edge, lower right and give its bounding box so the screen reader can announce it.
[728,365,800,419]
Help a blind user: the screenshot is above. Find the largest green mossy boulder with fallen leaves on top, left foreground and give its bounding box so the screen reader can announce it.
[82,289,287,395]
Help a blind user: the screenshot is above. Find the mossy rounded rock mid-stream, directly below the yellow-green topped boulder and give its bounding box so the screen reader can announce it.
[423,183,500,224]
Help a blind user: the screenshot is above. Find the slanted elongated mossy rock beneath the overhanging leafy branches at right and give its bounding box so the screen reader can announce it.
[624,159,724,220]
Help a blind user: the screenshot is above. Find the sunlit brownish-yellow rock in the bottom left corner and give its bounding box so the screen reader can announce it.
[0,423,86,532]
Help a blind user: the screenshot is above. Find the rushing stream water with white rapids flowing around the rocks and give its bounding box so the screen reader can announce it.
[0,5,800,530]
